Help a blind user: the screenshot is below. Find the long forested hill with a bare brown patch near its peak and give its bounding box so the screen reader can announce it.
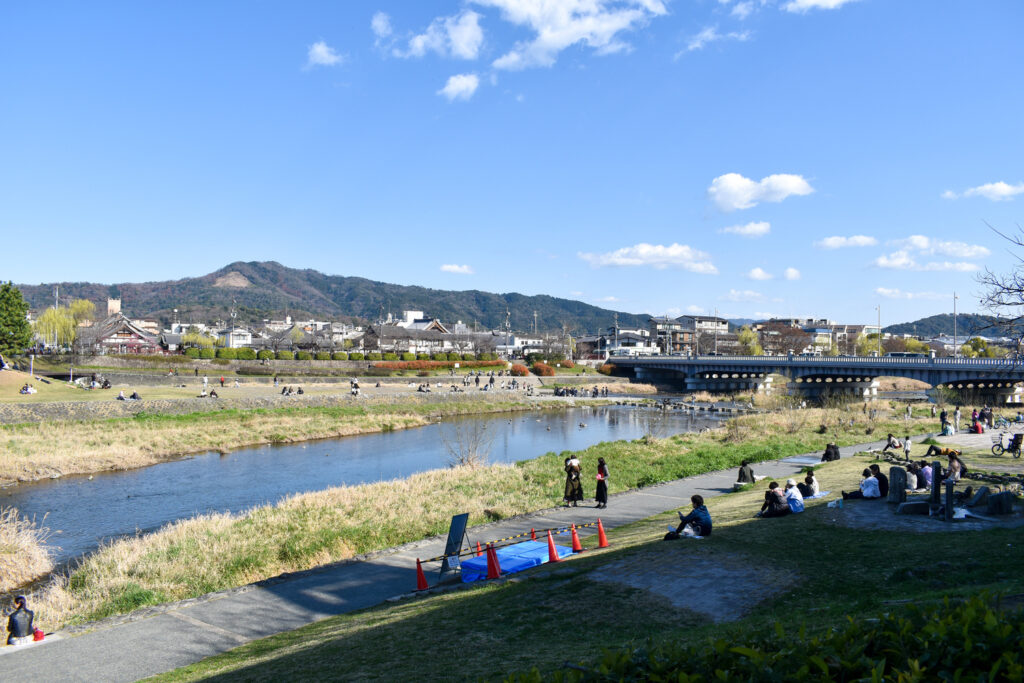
[18,261,649,335]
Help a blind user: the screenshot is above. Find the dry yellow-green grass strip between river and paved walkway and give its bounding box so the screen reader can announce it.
[22,411,937,628]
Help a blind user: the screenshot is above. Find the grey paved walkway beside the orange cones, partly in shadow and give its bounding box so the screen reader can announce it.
[0,441,897,682]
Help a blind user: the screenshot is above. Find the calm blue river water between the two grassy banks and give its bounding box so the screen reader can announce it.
[0,405,716,563]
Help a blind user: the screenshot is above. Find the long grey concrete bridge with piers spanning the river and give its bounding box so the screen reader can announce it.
[608,355,1024,403]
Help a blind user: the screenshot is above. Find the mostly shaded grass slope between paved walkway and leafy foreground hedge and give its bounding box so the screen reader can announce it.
[151,448,1024,683]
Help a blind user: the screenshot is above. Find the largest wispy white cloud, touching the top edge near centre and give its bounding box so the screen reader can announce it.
[472,0,668,71]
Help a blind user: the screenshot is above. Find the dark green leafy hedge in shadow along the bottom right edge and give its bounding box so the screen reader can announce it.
[506,594,1024,683]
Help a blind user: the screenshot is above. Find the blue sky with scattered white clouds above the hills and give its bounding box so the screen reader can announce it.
[0,0,1024,324]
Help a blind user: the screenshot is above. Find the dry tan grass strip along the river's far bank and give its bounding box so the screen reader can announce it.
[0,397,548,486]
